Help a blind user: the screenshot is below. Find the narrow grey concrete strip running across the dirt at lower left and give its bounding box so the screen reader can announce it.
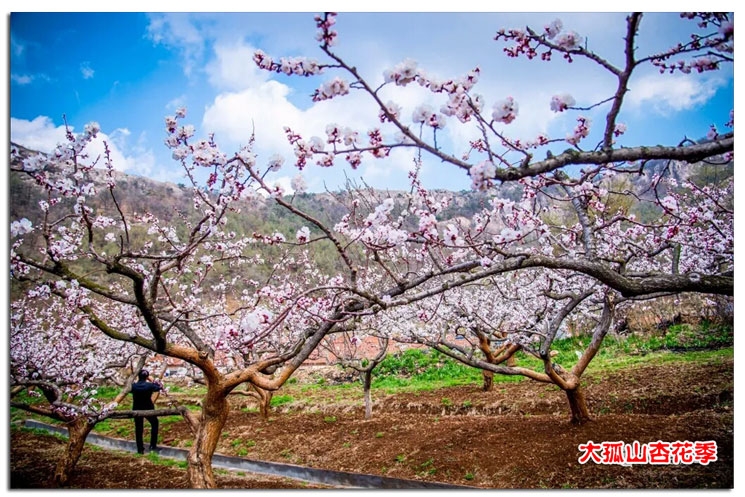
[24,420,475,489]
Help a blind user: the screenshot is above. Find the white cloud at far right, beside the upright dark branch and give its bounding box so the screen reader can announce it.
[628,73,726,115]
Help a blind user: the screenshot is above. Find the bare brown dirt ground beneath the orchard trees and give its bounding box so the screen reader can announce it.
[11,360,734,488]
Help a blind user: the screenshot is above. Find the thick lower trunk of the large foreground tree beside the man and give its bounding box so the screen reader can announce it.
[186,386,230,488]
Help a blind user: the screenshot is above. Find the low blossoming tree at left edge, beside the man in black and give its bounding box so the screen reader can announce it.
[10,292,185,485]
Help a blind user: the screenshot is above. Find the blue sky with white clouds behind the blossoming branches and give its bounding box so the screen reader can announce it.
[8,12,734,191]
